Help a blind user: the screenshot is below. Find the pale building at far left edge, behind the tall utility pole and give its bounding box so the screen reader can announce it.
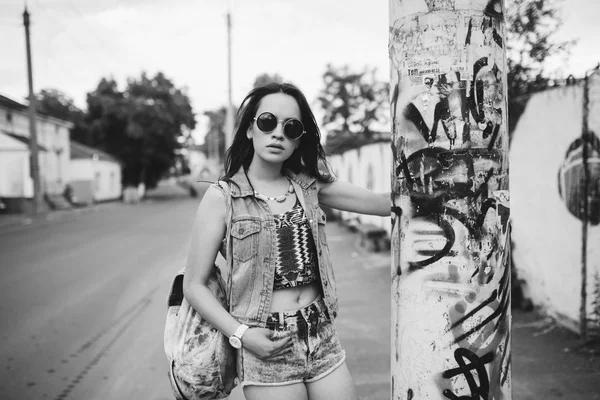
[0,95,72,212]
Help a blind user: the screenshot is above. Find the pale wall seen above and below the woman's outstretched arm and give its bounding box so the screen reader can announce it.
[327,142,392,233]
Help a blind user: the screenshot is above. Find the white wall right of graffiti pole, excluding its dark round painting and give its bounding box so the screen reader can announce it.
[510,77,600,329]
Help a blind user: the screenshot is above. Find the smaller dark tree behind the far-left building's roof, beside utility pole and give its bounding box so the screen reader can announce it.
[35,89,90,144]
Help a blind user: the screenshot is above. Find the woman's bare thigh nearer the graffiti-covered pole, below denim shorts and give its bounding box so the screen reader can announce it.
[306,362,358,400]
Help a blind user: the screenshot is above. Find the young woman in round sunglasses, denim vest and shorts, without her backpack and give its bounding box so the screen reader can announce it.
[184,83,390,400]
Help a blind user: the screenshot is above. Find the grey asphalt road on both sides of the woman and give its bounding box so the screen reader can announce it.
[0,192,390,400]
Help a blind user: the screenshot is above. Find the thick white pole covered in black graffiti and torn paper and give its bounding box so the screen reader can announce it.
[389,0,512,400]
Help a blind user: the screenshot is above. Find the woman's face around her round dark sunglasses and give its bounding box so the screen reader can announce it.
[246,93,302,164]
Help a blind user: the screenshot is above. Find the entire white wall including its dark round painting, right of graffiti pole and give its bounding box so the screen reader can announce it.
[510,71,600,332]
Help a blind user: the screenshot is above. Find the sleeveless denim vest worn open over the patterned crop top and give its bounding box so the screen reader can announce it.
[217,168,338,327]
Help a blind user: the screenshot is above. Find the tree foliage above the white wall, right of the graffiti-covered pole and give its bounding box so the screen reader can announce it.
[506,0,575,132]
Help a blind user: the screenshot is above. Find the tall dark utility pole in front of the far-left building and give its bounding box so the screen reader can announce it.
[23,7,42,214]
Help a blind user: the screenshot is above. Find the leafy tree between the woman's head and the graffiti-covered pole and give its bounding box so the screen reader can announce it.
[317,64,389,147]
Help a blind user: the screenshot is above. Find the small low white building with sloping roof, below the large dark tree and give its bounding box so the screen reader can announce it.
[69,141,122,204]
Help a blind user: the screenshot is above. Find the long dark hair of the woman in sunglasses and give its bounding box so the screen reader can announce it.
[223,82,333,182]
